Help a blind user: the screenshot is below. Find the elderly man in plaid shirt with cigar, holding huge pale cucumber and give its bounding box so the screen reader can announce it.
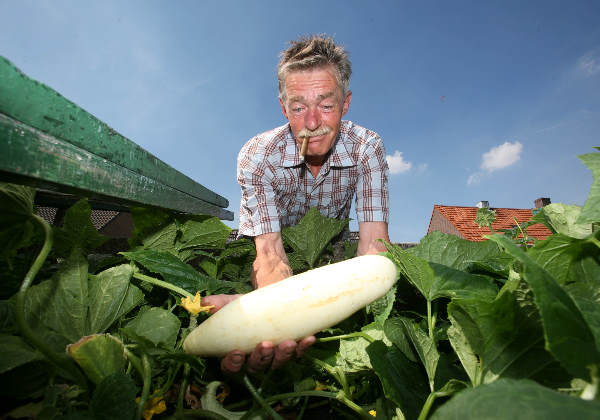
[205,36,389,372]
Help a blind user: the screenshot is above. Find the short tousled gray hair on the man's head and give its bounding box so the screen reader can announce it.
[277,35,352,102]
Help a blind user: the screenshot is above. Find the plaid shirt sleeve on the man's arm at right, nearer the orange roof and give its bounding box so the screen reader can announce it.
[356,135,389,223]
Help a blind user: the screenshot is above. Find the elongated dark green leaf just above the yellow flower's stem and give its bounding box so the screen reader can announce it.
[121,249,229,294]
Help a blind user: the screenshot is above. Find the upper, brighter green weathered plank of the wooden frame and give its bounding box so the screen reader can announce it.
[0,56,229,208]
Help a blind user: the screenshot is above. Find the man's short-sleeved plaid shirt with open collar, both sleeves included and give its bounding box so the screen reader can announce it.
[237,121,388,236]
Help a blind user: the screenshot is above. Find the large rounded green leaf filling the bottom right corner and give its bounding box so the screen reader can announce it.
[431,379,600,420]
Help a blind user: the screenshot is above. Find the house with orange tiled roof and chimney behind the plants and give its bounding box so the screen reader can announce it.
[427,198,552,242]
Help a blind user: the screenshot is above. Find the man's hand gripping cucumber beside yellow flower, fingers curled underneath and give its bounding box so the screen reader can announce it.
[202,295,315,374]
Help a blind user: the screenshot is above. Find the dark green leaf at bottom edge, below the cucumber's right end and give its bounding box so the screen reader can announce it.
[366,341,429,419]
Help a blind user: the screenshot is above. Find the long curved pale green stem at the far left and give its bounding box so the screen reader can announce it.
[16,215,88,390]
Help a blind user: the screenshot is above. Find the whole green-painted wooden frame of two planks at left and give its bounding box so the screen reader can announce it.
[0,57,233,220]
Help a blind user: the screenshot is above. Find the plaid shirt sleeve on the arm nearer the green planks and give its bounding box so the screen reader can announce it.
[237,141,280,236]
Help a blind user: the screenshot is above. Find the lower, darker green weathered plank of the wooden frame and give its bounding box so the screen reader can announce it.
[0,113,233,220]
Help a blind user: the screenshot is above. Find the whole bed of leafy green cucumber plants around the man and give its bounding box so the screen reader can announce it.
[0,149,600,419]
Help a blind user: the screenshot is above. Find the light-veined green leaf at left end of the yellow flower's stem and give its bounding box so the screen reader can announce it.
[89,264,144,334]
